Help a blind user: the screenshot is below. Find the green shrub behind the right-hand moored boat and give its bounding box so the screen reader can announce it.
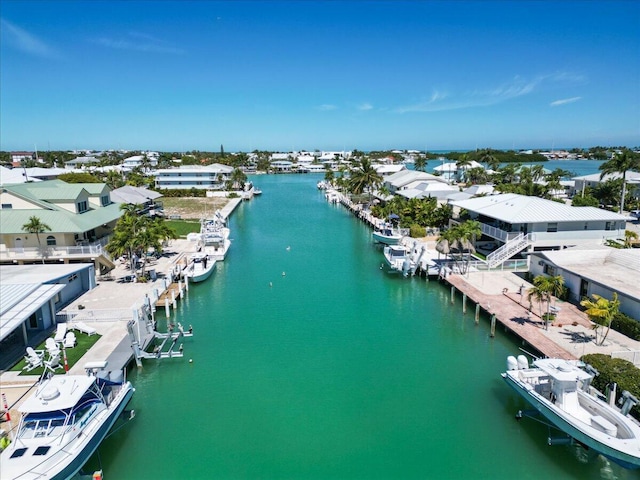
[580,353,640,419]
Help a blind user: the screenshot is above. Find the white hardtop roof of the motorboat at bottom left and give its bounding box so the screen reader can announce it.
[18,375,95,413]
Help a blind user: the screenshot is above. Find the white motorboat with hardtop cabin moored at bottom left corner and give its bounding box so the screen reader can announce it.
[0,362,135,480]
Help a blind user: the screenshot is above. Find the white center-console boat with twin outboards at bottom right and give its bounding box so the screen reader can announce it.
[502,355,640,469]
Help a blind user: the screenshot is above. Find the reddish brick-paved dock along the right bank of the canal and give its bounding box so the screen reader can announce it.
[444,275,577,360]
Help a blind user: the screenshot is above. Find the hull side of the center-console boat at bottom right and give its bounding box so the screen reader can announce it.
[502,373,640,469]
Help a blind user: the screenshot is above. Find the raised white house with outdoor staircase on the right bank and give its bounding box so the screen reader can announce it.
[450,193,629,267]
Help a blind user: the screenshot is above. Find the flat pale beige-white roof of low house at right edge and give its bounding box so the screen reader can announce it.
[534,245,640,299]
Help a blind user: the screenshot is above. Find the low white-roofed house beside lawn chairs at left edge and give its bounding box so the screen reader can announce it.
[0,263,96,369]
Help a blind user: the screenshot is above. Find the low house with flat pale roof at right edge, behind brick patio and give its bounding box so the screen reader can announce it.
[529,245,640,321]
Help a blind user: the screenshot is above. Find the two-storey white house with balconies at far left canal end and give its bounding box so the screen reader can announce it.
[156,163,233,190]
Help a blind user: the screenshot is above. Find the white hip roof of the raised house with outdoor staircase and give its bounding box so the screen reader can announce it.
[451,193,628,223]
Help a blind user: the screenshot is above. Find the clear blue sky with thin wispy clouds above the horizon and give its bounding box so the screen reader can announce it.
[0,0,640,151]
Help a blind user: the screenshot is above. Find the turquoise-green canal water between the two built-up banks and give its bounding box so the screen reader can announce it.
[90,175,637,480]
